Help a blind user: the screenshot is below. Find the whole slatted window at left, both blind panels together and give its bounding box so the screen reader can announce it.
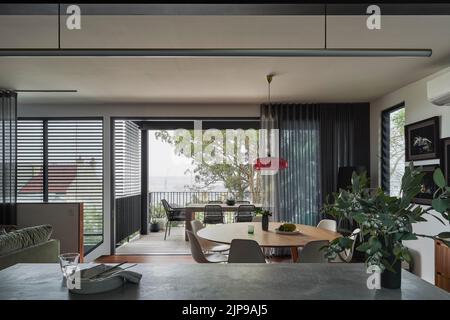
[17,119,103,253]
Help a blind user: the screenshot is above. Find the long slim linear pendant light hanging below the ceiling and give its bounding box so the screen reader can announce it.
[0,48,432,58]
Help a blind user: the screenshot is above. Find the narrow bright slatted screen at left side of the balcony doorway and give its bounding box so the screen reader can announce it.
[114,120,141,198]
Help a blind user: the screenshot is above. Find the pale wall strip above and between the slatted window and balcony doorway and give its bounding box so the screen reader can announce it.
[18,102,259,261]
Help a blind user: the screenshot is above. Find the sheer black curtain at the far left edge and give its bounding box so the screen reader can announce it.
[0,89,17,225]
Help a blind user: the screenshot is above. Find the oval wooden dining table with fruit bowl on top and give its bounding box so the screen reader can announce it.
[197,222,342,262]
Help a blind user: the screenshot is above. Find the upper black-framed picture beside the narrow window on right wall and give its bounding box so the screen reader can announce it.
[405,117,440,161]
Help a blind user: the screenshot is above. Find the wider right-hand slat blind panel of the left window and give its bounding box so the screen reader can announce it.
[48,120,103,246]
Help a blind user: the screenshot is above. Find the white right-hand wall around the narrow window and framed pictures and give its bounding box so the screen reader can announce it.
[370,68,450,283]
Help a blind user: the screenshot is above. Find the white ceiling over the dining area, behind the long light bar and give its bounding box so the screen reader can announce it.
[0,16,450,104]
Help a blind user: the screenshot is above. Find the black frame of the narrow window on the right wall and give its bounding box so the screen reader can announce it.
[380,101,406,194]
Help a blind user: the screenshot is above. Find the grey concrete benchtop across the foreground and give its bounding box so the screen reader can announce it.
[0,263,450,300]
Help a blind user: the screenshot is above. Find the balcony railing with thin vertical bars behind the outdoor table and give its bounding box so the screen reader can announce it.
[149,191,261,223]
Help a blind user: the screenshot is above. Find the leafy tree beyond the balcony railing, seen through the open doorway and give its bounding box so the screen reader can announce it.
[155,130,261,202]
